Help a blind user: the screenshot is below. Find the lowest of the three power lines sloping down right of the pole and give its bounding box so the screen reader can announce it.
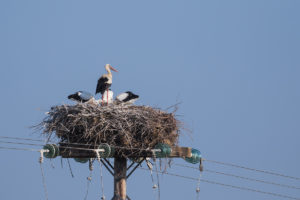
[140,167,300,200]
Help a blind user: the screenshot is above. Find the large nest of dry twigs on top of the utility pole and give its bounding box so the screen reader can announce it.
[39,103,179,157]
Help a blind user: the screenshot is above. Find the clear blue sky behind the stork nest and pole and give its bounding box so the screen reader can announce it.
[0,0,300,200]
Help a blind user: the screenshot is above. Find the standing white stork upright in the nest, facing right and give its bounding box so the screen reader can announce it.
[96,64,118,105]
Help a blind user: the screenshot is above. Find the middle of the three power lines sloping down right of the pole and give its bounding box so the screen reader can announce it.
[173,164,300,190]
